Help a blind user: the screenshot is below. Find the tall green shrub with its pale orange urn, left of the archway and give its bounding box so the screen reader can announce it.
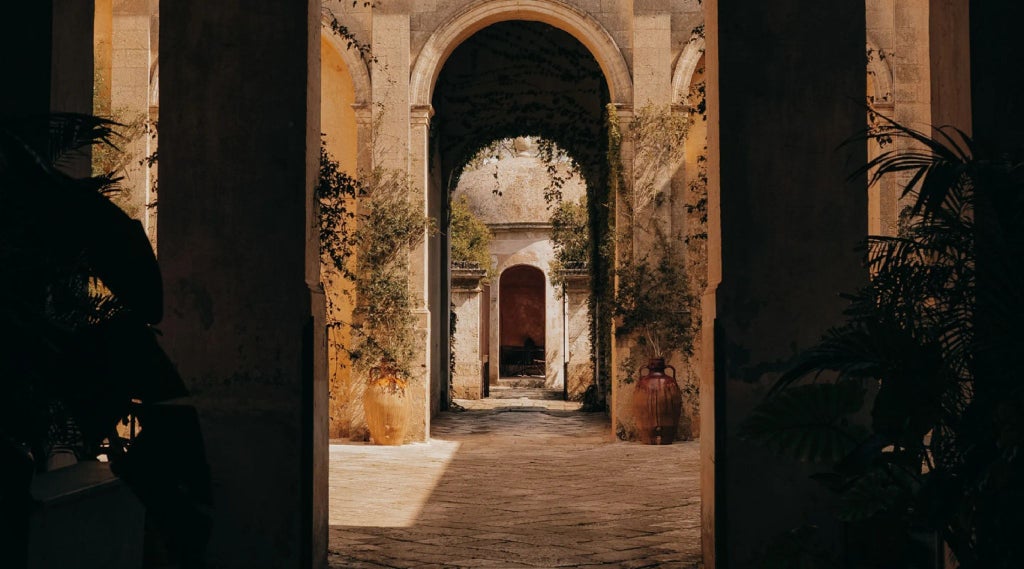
[317,151,430,445]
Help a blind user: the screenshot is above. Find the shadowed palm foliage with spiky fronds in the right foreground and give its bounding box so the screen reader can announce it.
[744,118,1024,569]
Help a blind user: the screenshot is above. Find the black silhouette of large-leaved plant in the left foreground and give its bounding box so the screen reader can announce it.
[0,115,210,566]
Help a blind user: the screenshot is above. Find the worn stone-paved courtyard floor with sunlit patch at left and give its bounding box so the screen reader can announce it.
[329,401,700,569]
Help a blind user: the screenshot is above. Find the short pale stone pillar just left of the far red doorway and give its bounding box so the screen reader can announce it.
[450,269,486,399]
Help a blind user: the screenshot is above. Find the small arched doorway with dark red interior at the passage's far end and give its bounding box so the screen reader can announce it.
[498,265,547,377]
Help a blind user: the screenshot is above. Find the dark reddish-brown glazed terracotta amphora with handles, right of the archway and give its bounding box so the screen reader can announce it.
[633,357,682,444]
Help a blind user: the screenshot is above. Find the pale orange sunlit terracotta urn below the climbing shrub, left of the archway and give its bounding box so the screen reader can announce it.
[362,364,410,445]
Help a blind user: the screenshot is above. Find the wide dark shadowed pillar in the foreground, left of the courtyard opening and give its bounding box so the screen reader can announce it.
[160,0,328,568]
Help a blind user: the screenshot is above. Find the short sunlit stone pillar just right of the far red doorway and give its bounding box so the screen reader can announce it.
[565,270,594,399]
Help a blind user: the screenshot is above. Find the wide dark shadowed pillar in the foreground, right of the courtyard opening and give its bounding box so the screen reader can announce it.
[701,0,867,569]
